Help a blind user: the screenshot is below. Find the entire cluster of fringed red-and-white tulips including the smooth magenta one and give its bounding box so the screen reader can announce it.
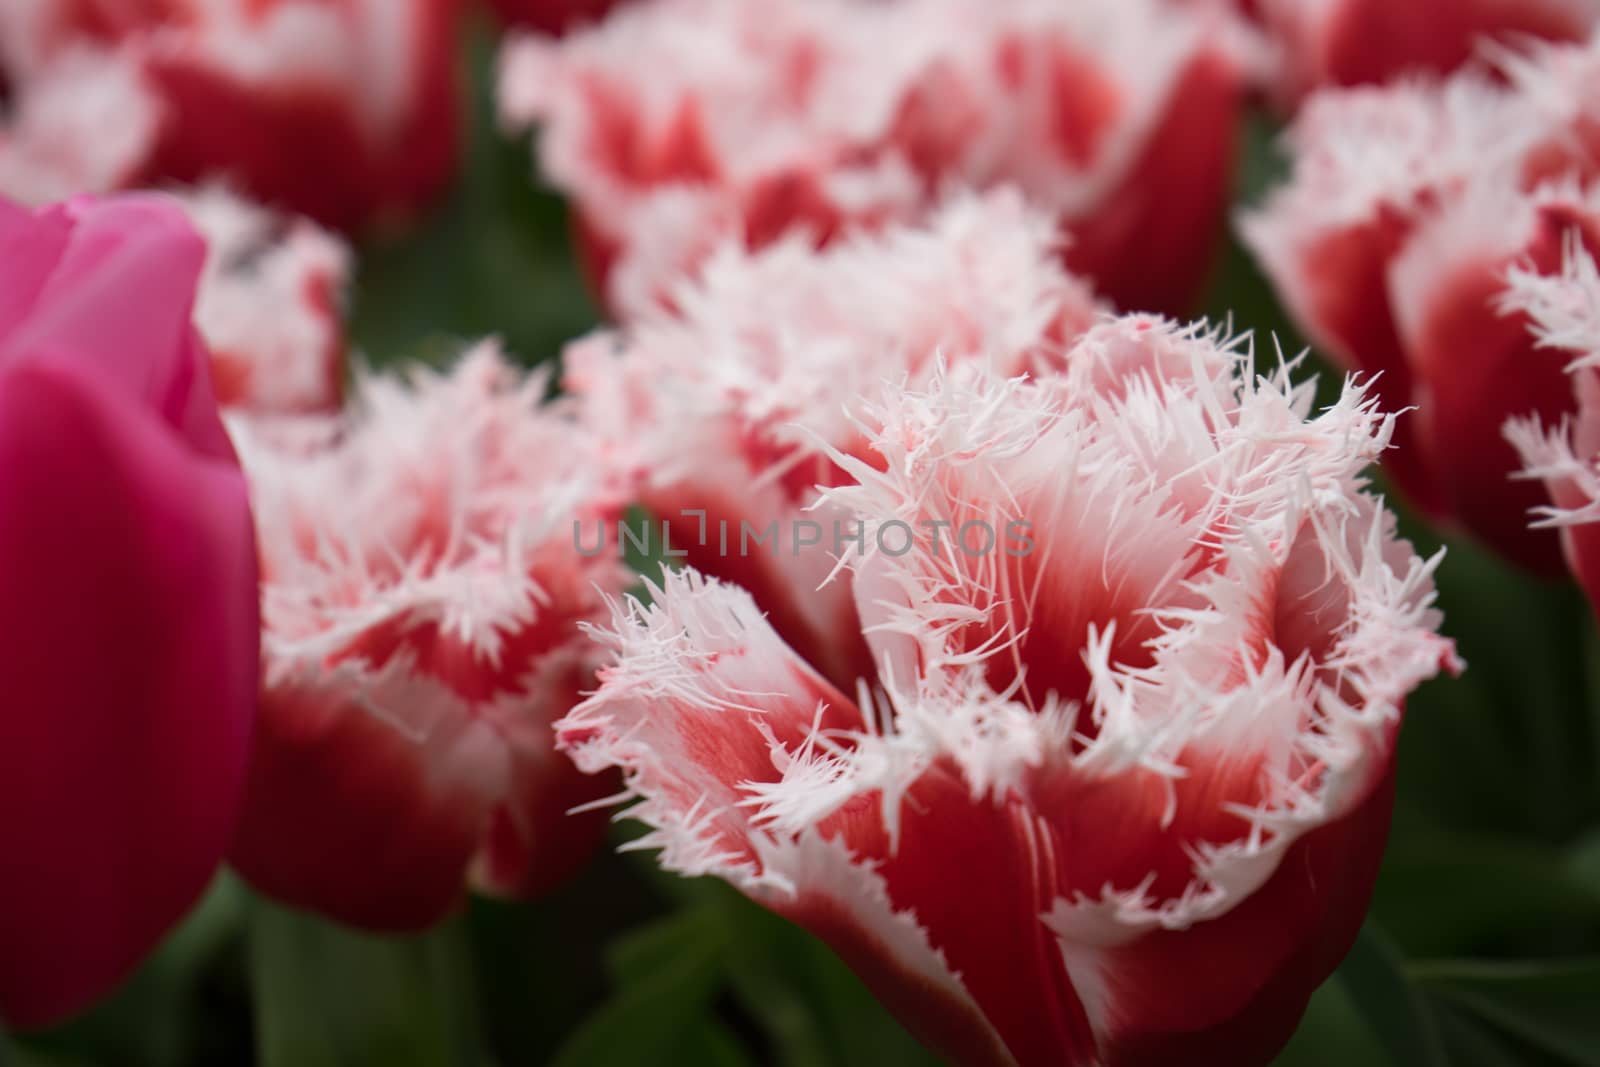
[0,0,1600,1067]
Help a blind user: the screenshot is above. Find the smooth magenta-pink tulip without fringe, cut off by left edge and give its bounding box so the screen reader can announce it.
[0,197,259,1027]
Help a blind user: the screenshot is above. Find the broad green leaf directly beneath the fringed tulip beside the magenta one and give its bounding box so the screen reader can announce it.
[250,901,482,1067]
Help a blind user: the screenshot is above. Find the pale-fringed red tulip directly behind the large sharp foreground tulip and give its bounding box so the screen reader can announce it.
[563,192,1096,685]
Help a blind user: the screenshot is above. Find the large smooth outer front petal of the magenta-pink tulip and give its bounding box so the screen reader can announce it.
[0,366,259,1025]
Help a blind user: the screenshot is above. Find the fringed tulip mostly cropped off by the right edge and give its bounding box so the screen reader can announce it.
[1504,242,1600,605]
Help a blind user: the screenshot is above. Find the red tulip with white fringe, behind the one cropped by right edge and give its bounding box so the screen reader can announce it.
[1240,45,1600,573]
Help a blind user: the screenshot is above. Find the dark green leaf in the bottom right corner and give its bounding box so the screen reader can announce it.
[1410,960,1600,1067]
